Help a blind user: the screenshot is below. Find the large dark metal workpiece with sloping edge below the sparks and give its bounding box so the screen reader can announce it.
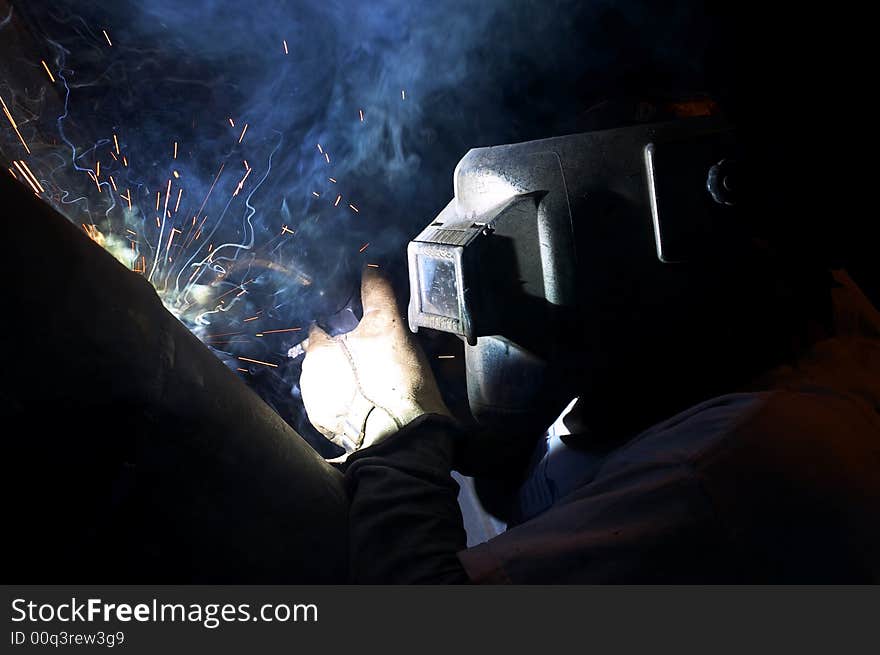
[0,172,348,583]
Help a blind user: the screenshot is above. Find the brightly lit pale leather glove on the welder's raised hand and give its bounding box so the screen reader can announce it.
[300,268,451,461]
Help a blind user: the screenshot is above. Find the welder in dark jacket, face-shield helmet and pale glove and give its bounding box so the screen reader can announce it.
[301,104,880,583]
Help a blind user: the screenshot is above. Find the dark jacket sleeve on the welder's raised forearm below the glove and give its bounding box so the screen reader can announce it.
[345,415,468,584]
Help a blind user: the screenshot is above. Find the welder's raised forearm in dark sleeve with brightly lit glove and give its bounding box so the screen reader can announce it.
[300,269,467,583]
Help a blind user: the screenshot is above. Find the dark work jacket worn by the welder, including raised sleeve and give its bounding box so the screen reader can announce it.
[346,272,880,583]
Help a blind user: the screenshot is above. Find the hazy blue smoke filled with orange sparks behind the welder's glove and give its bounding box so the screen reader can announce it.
[0,0,728,452]
